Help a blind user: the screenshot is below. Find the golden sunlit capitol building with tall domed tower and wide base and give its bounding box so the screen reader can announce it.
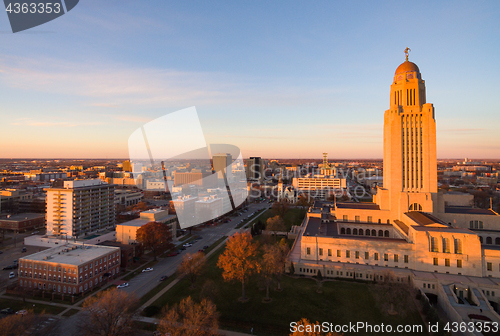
[289,51,500,322]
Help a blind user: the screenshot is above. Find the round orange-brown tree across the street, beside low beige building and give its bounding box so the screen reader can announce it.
[135,222,174,260]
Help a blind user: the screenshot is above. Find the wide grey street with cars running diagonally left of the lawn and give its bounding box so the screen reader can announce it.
[122,202,271,297]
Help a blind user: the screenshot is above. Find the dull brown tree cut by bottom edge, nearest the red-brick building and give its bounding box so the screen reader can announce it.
[80,289,139,336]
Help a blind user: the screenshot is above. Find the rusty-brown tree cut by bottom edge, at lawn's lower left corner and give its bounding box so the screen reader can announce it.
[158,296,219,336]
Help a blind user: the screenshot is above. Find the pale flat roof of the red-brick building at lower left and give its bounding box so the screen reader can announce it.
[20,243,120,266]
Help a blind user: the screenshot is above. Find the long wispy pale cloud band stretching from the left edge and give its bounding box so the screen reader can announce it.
[0,56,345,108]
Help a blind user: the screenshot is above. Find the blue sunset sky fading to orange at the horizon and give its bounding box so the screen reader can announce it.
[0,0,500,160]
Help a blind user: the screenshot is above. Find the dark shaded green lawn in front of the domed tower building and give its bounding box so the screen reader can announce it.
[153,240,422,335]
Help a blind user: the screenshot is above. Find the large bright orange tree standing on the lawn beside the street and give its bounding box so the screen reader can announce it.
[217,232,260,301]
